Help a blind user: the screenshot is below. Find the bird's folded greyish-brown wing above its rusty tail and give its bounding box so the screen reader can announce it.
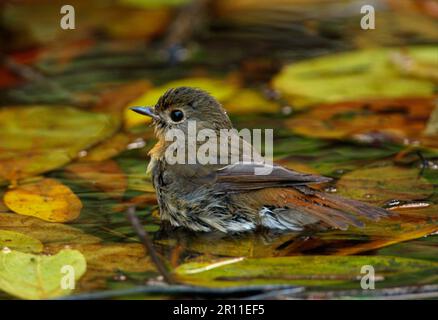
[215,163,331,193]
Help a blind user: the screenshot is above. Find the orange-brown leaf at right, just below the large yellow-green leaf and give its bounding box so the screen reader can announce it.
[287,98,435,144]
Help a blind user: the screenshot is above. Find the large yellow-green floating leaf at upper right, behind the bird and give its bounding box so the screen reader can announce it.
[273,46,438,108]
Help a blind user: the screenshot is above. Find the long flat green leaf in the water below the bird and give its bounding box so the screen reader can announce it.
[175,255,438,288]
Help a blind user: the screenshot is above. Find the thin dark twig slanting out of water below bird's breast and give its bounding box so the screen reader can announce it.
[126,207,175,284]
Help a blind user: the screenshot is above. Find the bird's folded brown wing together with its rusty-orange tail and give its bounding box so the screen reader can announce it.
[216,163,389,230]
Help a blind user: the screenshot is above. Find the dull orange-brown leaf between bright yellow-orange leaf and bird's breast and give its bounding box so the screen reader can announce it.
[65,160,128,198]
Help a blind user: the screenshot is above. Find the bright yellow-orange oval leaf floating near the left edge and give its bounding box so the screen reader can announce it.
[4,179,82,222]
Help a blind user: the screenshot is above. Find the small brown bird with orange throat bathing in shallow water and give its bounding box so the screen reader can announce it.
[132,87,389,233]
